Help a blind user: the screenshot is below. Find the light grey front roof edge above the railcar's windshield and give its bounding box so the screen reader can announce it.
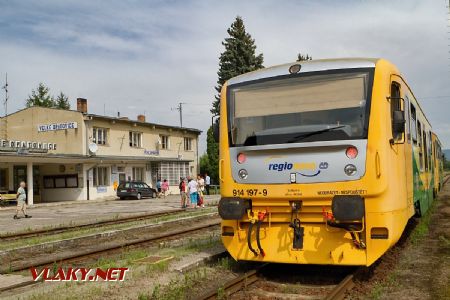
[228,58,379,85]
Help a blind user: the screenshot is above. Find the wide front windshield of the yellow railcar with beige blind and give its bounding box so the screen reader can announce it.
[228,70,371,146]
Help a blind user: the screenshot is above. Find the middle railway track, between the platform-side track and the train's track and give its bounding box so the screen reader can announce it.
[0,214,220,298]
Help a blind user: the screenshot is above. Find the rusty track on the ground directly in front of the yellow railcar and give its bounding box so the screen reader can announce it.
[198,264,356,300]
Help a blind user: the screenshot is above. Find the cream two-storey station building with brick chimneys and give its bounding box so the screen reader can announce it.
[0,98,201,204]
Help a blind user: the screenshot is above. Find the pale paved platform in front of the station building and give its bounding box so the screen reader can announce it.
[0,195,220,234]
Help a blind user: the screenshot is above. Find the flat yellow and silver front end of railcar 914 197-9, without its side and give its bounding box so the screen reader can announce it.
[219,60,398,265]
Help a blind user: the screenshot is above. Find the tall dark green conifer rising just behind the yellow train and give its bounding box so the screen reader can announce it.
[206,16,264,184]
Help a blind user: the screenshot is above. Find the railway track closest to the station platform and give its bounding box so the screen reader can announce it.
[0,209,186,242]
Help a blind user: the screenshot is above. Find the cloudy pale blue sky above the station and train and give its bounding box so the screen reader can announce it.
[0,0,450,152]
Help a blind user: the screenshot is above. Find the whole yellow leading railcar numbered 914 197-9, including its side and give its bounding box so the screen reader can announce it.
[217,58,434,265]
